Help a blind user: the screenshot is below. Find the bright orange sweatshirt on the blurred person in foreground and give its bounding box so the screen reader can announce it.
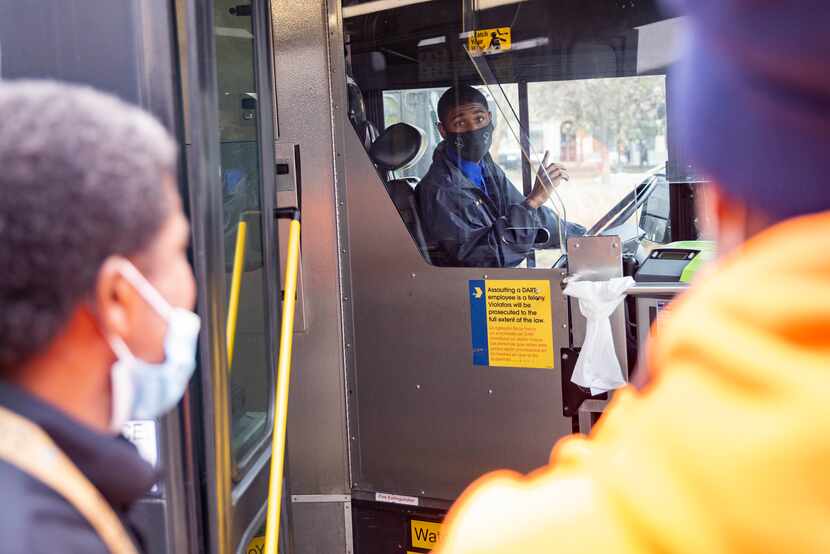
[435,212,830,554]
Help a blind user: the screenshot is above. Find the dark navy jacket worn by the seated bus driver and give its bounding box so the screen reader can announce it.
[416,142,585,267]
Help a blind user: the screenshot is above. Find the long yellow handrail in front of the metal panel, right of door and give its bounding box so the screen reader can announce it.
[265,218,300,554]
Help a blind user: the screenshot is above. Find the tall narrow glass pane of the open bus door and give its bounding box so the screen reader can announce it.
[214,0,272,465]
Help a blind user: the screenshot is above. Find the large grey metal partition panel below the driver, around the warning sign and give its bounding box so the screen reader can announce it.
[345,129,571,499]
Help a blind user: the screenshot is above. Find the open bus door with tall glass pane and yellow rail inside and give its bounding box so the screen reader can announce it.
[176,0,280,553]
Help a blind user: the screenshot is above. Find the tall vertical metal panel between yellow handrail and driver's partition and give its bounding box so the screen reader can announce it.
[271,0,349,494]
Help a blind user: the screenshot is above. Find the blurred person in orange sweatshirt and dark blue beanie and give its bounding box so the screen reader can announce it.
[434,0,830,554]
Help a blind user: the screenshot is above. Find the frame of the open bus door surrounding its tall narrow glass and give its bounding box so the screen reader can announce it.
[182,0,280,554]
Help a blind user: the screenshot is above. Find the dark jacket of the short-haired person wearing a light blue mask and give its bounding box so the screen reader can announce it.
[0,381,159,554]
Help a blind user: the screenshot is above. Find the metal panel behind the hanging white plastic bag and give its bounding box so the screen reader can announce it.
[568,233,628,379]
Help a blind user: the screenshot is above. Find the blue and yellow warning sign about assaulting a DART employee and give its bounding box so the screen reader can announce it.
[469,280,553,369]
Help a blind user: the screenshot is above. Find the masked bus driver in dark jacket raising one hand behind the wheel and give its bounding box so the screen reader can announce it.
[416,85,585,267]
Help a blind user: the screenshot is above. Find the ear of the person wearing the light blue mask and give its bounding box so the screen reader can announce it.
[95,257,141,339]
